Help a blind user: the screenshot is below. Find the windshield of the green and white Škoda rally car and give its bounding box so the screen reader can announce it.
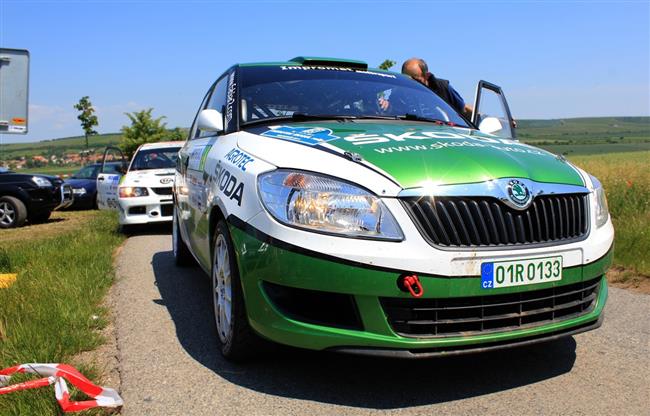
[240,66,468,127]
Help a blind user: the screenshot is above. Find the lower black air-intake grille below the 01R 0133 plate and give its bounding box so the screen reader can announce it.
[380,277,601,337]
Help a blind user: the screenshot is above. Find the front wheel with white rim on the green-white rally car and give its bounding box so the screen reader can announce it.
[211,220,261,361]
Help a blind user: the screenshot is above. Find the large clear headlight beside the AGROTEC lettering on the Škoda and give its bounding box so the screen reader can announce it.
[258,170,404,240]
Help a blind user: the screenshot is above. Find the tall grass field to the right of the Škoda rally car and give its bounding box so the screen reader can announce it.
[570,152,650,276]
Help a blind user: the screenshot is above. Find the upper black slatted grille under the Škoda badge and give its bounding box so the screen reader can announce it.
[401,194,589,248]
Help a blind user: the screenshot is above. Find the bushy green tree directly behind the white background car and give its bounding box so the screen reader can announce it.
[120,108,169,158]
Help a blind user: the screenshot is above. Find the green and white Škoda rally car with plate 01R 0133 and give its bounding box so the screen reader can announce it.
[173,57,614,359]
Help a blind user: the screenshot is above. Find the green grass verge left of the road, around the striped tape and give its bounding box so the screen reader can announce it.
[0,211,124,415]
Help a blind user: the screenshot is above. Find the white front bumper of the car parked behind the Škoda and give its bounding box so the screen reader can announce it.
[119,192,173,225]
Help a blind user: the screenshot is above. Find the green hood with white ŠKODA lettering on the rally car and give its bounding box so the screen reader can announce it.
[247,121,584,189]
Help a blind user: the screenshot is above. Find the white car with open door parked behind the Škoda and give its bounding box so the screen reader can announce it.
[97,142,184,225]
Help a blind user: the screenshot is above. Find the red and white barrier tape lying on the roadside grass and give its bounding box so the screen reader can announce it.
[0,363,124,413]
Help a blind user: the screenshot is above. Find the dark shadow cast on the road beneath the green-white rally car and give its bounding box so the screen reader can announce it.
[152,252,576,409]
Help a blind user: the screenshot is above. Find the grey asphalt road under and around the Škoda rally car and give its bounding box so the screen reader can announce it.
[113,230,650,415]
